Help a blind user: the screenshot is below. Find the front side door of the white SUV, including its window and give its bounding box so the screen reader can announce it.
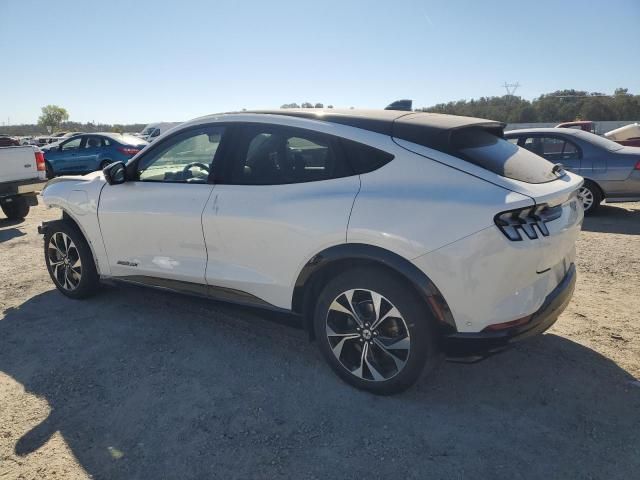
[98,126,224,285]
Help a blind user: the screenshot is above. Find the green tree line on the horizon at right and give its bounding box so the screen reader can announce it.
[418,88,640,123]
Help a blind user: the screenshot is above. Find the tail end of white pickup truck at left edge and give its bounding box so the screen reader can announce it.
[0,145,46,220]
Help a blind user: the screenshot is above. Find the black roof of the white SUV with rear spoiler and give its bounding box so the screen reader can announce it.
[238,108,505,151]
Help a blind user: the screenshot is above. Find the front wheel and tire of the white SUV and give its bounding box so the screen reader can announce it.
[44,220,100,299]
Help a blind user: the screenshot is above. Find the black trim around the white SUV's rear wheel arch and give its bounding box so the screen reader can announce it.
[291,243,457,336]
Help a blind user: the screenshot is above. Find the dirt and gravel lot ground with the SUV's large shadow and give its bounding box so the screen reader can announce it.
[0,203,640,480]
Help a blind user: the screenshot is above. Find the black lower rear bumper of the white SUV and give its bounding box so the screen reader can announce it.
[443,264,576,357]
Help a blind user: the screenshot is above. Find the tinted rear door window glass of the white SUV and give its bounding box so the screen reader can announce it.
[230,125,353,185]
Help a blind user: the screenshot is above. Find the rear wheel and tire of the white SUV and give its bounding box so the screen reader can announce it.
[313,267,439,395]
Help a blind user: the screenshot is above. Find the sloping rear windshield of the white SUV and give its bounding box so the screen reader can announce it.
[451,128,558,183]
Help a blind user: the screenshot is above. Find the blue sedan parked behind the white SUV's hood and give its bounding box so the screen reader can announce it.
[42,133,148,178]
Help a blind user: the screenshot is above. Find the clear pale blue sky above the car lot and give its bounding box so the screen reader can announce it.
[0,0,640,125]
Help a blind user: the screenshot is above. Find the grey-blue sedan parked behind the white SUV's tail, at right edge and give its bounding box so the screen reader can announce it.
[504,128,640,214]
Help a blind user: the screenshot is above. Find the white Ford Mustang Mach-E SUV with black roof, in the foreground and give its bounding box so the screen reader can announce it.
[40,109,583,393]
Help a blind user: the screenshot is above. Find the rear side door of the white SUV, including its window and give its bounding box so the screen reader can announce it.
[202,124,360,308]
